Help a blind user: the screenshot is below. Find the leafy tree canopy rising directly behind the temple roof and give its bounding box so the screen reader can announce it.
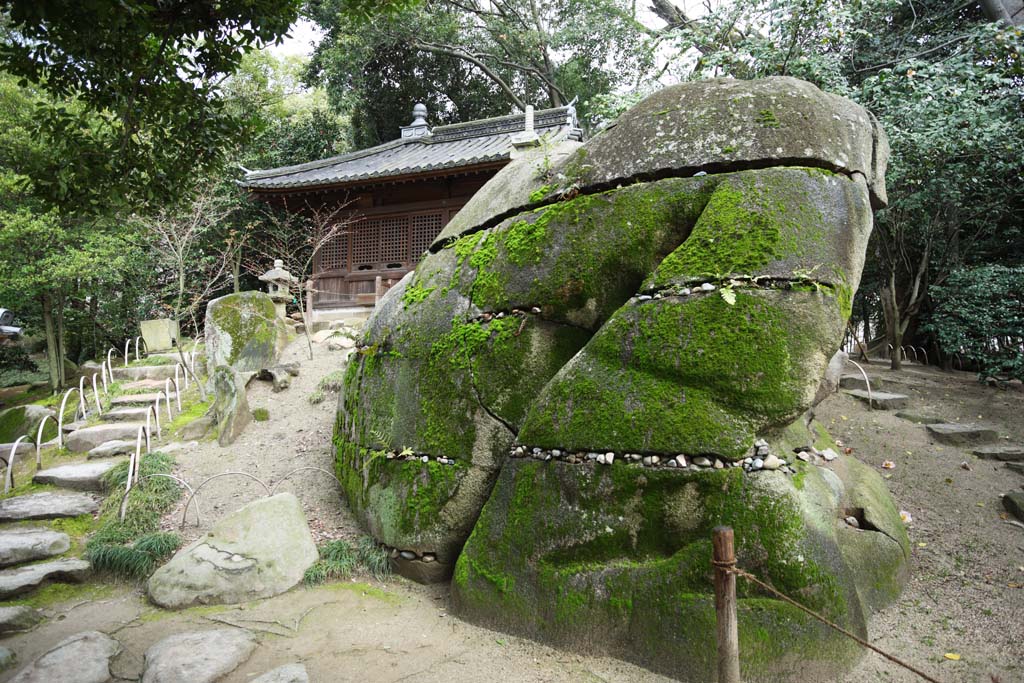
[307,0,653,146]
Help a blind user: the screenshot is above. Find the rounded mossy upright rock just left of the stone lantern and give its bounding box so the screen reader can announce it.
[205,292,288,381]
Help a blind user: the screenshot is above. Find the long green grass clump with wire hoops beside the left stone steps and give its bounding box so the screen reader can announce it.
[85,452,181,580]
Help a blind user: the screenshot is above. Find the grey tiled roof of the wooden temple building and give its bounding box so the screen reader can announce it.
[240,106,581,193]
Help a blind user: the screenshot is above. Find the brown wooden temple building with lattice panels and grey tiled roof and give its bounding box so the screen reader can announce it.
[241,104,581,323]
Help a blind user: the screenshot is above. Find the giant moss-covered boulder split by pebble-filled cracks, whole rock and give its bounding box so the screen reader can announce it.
[335,78,905,680]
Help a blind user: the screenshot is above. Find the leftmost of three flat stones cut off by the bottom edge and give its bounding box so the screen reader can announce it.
[11,631,121,683]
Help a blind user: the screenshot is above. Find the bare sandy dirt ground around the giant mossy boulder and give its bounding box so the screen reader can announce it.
[0,339,1024,683]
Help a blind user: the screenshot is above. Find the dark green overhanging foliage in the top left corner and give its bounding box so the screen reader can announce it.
[0,0,300,213]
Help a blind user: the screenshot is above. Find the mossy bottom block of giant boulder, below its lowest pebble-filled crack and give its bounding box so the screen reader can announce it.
[453,460,864,681]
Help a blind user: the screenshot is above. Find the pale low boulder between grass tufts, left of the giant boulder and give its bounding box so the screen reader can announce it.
[147,494,318,609]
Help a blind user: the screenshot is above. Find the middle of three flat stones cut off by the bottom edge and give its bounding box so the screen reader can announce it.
[142,629,256,683]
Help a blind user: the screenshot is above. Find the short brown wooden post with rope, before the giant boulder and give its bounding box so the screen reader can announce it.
[712,526,942,683]
